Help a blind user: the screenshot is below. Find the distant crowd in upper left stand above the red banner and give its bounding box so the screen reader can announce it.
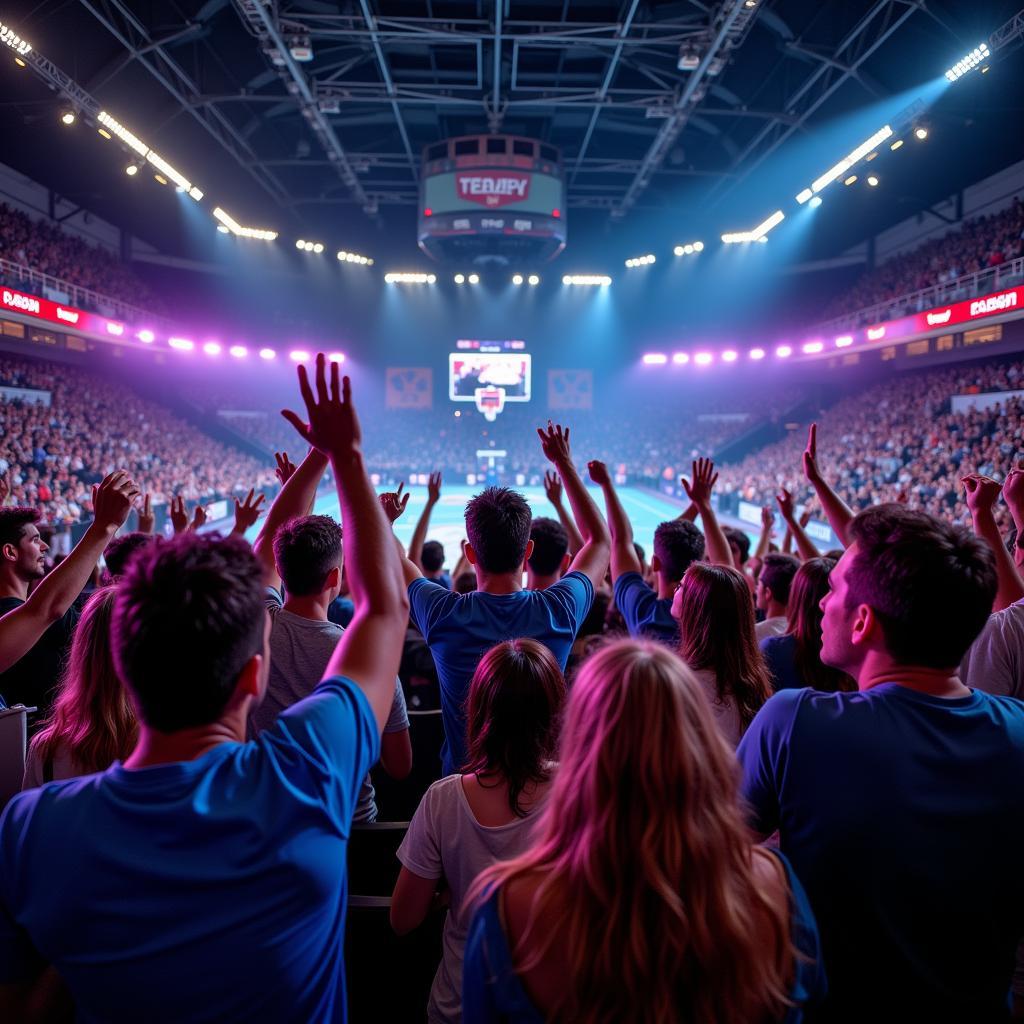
[0,203,166,313]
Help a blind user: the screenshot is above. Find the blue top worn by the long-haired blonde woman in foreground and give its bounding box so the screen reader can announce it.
[462,850,827,1024]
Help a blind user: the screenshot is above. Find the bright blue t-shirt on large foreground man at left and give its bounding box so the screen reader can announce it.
[0,678,380,1024]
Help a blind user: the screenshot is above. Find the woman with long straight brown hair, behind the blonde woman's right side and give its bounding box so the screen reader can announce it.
[672,562,772,746]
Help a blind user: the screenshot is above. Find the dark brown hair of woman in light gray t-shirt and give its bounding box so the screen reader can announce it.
[463,639,565,817]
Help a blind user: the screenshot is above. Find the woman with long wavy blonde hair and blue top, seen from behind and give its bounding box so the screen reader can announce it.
[463,638,824,1024]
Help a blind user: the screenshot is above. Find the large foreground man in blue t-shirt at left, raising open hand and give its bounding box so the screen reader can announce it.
[0,355,409,1024]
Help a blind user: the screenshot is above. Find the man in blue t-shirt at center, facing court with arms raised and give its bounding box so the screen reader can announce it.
[404,423,608,775]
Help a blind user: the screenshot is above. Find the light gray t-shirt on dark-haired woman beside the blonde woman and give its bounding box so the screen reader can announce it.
[398,775,543,1024]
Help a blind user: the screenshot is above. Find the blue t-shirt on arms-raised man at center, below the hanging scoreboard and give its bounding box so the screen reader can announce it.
[409,572,594,775]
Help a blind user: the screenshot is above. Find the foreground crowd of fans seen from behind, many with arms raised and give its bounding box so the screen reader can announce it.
[0,357,1024,1024]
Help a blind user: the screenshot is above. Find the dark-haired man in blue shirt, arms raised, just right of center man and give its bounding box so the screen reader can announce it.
[590,459,732,648]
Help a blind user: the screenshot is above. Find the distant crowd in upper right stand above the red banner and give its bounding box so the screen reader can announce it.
[825,198,1024,316]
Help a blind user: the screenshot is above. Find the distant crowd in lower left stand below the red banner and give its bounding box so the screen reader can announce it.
[0,355,274,526]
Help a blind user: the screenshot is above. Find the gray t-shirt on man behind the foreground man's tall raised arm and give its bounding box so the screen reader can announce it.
[249,587,409,823]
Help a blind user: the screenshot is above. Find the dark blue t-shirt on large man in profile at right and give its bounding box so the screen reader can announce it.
[737,683,1024,1024]
